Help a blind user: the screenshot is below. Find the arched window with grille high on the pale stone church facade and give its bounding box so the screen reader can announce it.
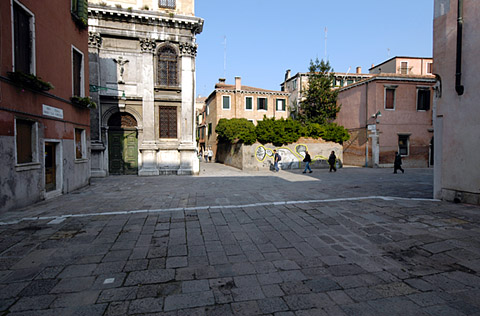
[157,46,178,87]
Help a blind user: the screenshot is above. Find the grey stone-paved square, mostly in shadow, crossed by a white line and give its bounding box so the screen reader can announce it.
[0,163,480,316]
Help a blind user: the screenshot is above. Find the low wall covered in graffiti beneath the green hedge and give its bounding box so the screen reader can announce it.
[215,138,343,170]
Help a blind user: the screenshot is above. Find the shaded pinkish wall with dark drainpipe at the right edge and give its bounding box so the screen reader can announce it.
[433,0,480,204]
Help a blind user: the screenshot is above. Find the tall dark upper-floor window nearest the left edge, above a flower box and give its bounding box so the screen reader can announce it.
[13,1,35,74]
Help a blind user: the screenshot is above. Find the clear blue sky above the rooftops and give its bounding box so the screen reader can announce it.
[195,0,433,96]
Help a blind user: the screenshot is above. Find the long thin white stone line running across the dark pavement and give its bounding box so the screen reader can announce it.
[0,195,440,226]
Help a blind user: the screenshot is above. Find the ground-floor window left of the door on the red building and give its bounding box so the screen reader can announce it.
[15,119,37,164]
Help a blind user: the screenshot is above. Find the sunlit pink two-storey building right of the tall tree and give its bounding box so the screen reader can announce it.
[336,73,435,168]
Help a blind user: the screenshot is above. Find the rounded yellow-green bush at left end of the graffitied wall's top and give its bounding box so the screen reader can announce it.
[215,118,257,145]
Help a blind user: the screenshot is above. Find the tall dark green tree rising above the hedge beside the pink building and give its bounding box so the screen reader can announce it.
[300,58,340,124]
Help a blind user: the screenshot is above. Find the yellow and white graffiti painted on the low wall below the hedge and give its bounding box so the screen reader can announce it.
[255,144,334,169]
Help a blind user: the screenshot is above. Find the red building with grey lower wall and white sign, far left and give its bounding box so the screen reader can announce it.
[0,0,90,211]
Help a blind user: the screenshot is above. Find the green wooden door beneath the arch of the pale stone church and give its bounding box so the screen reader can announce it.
[108,130,138,174]
